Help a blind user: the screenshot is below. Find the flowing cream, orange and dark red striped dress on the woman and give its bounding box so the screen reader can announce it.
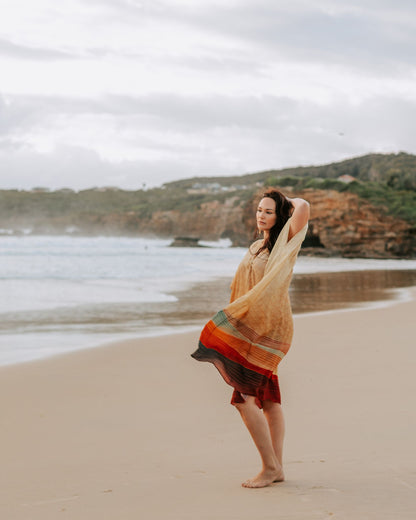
[192,219,307,406]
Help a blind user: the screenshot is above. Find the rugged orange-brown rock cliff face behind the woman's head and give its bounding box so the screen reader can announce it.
[132,188,416,258]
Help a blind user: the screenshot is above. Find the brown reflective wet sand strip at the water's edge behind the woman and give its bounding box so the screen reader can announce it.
[4,269,416,346]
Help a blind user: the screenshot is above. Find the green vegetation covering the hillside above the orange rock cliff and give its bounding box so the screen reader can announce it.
[0,153,416,228]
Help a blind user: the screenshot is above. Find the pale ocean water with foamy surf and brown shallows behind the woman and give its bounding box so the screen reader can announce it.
[0,235,416,365]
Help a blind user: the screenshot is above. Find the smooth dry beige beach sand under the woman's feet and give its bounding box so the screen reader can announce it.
[0,290,416,520]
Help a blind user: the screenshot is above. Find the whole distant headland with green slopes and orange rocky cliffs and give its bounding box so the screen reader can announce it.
[0,152,416,258]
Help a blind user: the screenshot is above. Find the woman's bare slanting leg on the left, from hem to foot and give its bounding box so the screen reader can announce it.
[235,396,284,488]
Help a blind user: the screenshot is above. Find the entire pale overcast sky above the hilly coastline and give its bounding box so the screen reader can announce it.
[0,0,416,189]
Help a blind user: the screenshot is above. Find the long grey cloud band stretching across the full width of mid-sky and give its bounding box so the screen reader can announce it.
[4,93,416,135]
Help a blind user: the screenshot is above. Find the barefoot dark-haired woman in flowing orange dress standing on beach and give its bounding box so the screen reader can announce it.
[192,189,309,488]
